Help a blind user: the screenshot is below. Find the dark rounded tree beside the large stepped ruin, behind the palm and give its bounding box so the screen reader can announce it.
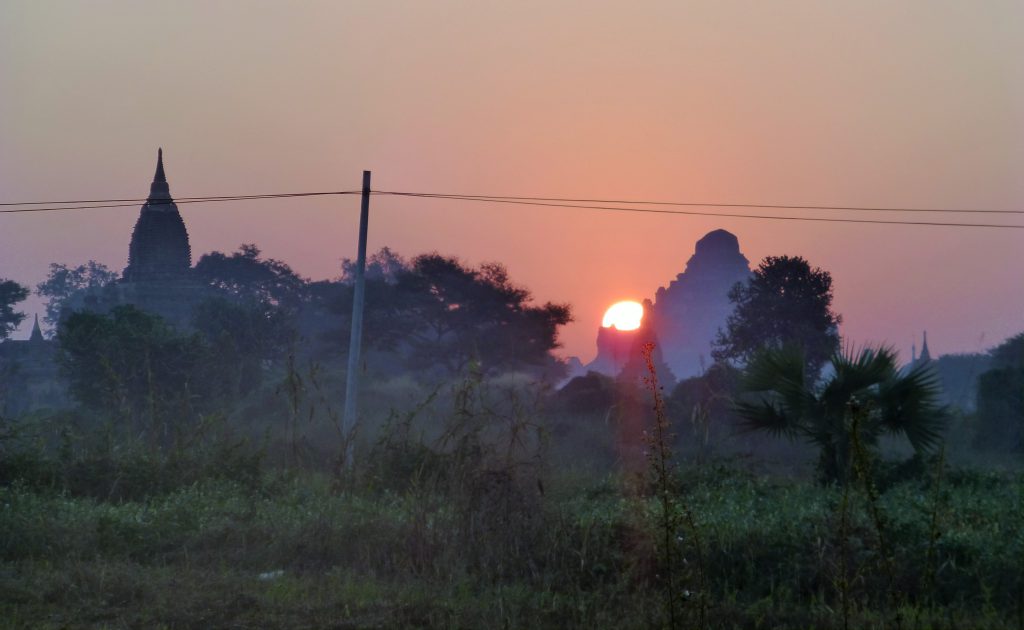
[712,256,843,380]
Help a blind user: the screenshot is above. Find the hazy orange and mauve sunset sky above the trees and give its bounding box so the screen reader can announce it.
[0,0,1024,361]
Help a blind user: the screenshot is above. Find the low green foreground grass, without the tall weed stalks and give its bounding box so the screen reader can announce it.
[0,452,1024,628]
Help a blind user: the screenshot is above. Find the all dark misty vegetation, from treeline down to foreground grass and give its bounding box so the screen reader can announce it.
[0,247,1024,629]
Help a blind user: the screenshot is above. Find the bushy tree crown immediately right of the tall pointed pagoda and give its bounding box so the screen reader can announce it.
[196,244,308,312]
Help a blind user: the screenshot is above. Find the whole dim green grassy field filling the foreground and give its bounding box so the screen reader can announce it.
[0,426,1024,629]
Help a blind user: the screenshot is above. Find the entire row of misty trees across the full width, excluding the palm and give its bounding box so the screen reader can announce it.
[0,245,1024,466]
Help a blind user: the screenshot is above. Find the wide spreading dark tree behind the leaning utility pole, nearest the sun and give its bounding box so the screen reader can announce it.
[314,249,571,376]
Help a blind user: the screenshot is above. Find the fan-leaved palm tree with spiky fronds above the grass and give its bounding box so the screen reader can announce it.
[736,347,944,484]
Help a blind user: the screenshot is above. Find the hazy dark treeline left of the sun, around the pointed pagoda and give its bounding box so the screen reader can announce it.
[0,245,571,430]
